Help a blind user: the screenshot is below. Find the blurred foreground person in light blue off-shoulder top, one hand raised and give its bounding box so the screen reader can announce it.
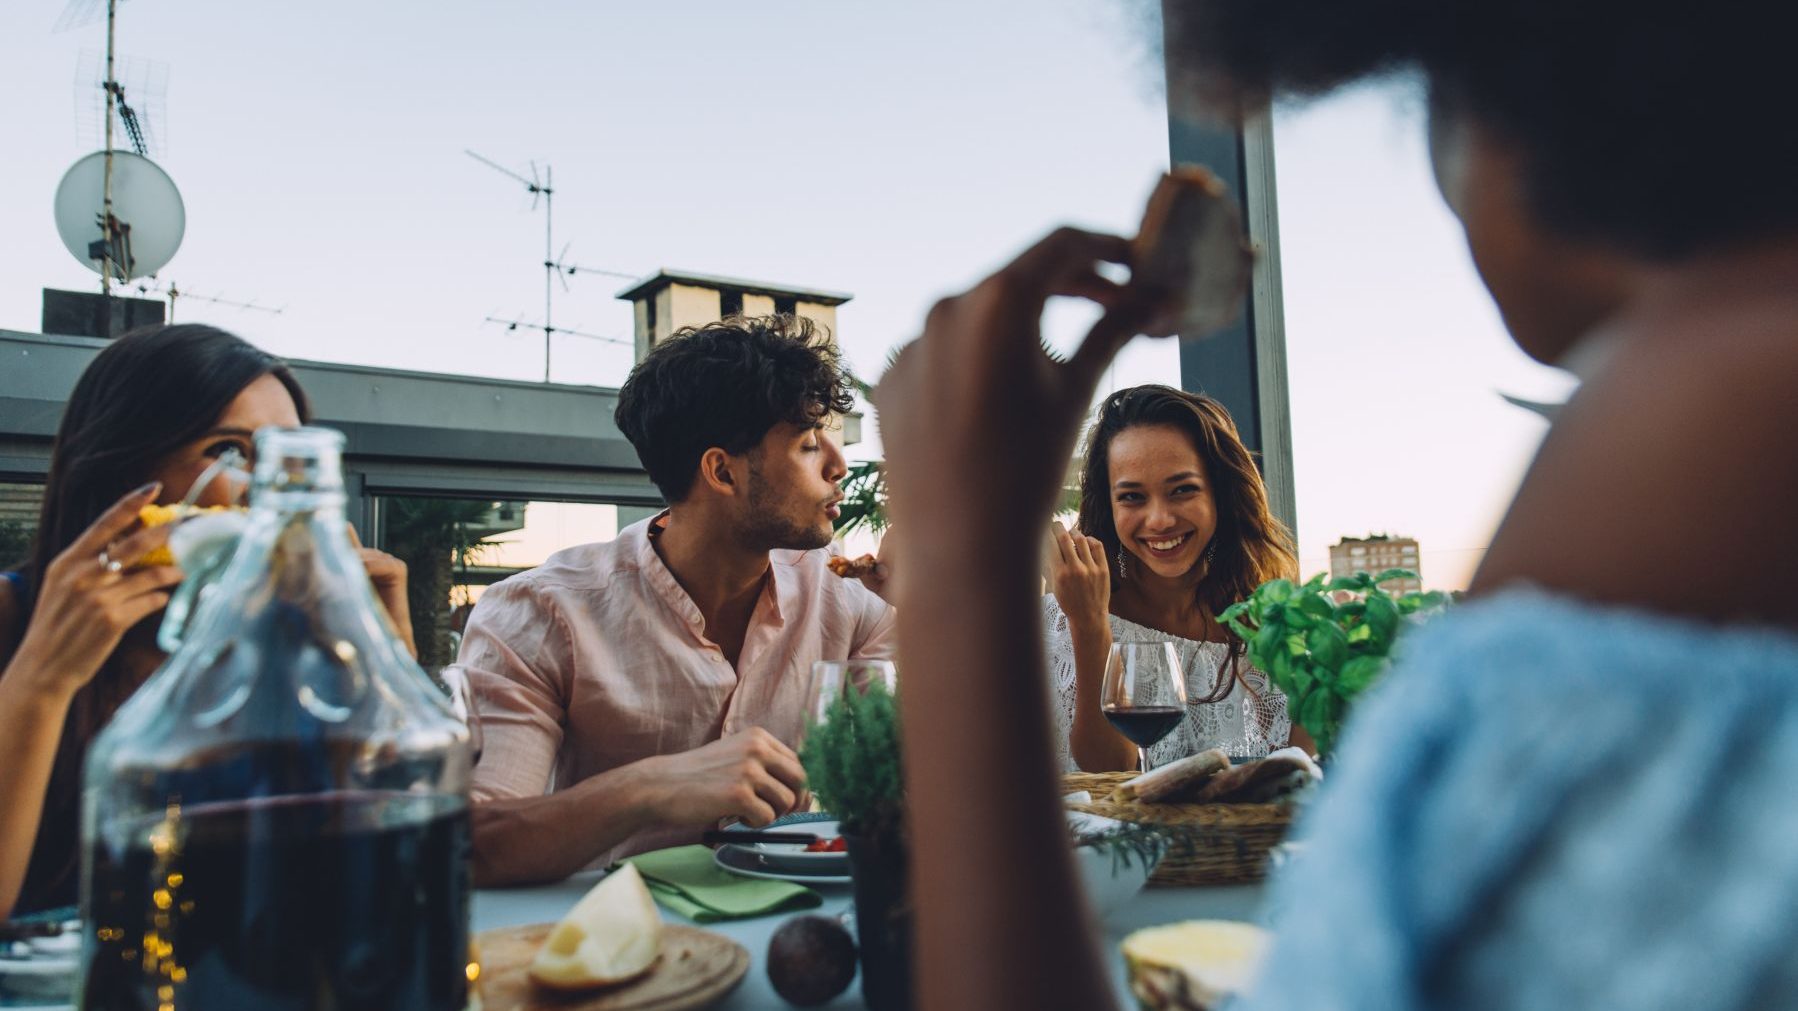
[859,0,1798,1011]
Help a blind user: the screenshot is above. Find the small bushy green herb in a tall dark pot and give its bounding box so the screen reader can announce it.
[800,682,912,1011]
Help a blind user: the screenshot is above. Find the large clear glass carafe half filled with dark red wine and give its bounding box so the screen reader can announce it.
[79,428,469,1011]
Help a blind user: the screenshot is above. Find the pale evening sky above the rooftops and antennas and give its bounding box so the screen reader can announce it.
[0,0,1570,586]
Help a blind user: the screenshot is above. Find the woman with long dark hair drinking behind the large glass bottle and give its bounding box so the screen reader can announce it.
[0,324,412,917]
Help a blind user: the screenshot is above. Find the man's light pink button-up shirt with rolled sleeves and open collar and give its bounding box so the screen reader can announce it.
[457,516,895,862]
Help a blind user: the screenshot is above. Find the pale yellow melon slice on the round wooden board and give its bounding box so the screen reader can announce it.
[530,863,662,989]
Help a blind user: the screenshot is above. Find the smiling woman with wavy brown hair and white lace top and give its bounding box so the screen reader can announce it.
[1043,385,1311,772]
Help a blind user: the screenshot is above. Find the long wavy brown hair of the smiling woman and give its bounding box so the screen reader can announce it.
[1081,385,1298,615]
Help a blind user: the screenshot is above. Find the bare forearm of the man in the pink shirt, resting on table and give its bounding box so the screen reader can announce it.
[475,763,654,889]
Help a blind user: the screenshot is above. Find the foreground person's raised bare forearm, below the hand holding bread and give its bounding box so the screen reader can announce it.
[899,543,1111,1011]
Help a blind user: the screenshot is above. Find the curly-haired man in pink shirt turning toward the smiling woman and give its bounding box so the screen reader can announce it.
[457,317,894,885]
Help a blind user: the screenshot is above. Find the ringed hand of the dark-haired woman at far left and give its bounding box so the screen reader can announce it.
[5,482,182,700]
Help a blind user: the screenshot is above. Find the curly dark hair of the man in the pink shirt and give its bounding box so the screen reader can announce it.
[613,313,856,502]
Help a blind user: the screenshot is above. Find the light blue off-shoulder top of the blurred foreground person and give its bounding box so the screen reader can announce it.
[1242,590,1798,1011]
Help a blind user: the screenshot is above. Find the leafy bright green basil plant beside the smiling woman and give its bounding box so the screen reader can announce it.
[1219,568,1449,757]
